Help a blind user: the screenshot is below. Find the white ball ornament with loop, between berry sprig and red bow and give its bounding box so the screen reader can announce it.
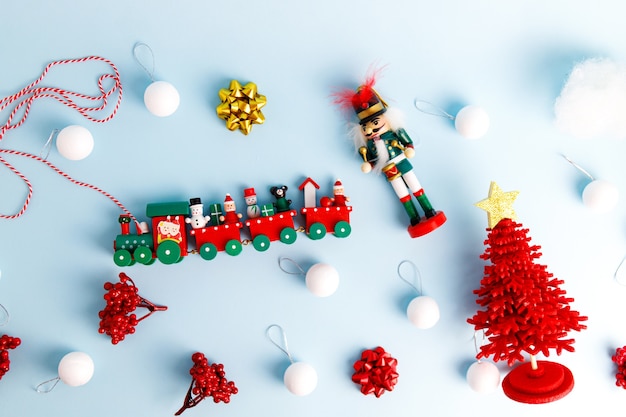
[266,324,318,396]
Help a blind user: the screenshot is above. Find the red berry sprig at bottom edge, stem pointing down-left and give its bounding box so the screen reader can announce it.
[175,352,239,416]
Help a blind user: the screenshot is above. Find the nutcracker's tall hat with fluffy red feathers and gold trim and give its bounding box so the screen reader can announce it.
[335,66,387,124]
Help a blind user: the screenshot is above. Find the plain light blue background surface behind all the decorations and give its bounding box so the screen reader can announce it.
[0,0,626,417]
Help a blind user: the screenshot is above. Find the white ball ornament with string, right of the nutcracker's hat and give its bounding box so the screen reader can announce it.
[413,100,491,139]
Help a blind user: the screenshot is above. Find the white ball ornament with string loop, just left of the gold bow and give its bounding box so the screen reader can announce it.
[133,42,180,117]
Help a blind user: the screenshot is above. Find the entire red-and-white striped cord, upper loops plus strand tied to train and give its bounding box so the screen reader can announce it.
[0,56,141,228]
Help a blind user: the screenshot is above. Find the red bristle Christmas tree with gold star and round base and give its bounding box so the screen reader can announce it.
[467,182,587,404]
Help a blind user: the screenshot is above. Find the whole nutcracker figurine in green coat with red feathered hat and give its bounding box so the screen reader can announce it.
[335,68,446,238]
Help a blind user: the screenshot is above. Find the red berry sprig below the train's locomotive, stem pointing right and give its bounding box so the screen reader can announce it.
[98,272,167,345]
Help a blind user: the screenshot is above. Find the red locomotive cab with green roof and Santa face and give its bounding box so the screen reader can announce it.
[146,201,189,264]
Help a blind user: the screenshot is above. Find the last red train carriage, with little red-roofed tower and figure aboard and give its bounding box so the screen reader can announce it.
[299,178,352,240]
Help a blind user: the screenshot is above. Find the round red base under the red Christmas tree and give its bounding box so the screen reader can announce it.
[502,361,574,404]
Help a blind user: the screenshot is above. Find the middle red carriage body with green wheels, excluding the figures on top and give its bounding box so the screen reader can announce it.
[246,210,297,252]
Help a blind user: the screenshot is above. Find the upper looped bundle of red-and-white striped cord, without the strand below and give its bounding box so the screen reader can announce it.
[0,56,122,140]
